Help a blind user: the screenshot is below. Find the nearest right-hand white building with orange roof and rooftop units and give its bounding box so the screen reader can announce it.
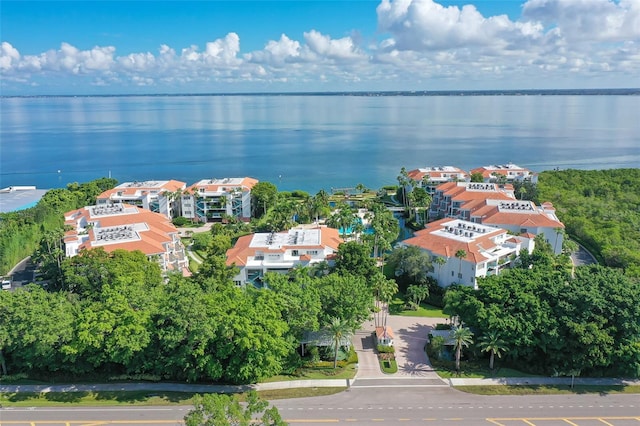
[400,218,534,288]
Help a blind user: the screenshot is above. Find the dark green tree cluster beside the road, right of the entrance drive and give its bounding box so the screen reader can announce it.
[445,243,640,377]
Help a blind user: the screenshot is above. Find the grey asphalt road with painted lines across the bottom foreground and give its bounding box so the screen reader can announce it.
[0,385,640,426]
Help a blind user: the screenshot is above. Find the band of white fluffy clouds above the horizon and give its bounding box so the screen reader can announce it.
[0,0,640,91]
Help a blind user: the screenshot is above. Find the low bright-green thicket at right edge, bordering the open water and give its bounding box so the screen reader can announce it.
[538,169,640,279]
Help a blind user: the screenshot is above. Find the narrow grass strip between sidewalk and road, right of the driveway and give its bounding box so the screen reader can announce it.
[456,385,640,395]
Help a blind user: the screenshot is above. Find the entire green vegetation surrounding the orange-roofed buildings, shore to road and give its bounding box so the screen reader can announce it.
[0,169,640,398]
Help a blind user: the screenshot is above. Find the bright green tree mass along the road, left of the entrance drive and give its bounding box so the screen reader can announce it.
[0,234,377,383]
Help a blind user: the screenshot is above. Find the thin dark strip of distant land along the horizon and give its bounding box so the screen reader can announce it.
[0,88,640,99]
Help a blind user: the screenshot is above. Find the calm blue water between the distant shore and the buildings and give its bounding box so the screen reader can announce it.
[0,95,640,193]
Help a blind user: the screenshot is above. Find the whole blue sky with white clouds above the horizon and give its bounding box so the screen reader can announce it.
[0,0,640,95]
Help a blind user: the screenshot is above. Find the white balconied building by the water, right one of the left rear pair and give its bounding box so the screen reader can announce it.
[180,177,258,222]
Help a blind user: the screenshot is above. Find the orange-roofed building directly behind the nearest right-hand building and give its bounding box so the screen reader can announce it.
[470,200,564,254]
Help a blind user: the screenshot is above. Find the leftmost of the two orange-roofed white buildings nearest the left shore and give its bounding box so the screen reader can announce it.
[96,180,187,218]
